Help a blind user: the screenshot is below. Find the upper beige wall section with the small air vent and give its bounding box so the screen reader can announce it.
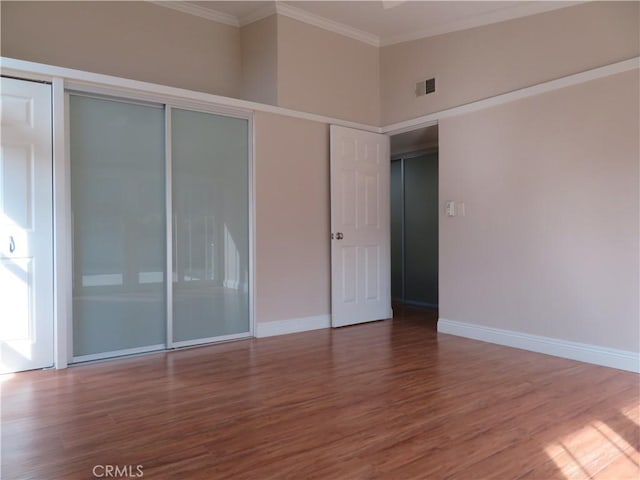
[381,2,640,125]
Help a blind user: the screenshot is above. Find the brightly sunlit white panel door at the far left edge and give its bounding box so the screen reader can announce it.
[0,78,53,373]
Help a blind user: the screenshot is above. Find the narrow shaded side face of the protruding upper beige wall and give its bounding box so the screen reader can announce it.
[240,15,278,105]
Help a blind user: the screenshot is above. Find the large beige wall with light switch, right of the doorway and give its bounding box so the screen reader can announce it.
[439,70,640,352]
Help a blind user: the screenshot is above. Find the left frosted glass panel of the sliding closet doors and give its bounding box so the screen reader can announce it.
[70,95,167,357]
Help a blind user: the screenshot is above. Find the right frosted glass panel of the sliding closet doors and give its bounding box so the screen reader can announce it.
[171,109,249,343]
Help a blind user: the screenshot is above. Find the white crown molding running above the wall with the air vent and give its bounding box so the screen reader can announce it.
[380,1,585,47]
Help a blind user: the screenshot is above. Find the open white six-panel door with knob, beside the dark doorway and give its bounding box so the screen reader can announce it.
[331,125,391,327]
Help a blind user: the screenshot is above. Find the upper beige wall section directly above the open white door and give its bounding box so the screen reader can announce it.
[278,16,380,125]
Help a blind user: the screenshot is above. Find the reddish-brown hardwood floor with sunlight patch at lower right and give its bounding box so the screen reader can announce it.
[1,309,640,480]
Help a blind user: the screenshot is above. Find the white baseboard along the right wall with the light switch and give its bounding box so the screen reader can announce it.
[438,318,640,373]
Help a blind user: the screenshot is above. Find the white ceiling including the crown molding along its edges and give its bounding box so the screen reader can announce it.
[176,0,582,46]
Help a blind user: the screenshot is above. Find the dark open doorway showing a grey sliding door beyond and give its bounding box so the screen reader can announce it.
[391,125,439,308]
